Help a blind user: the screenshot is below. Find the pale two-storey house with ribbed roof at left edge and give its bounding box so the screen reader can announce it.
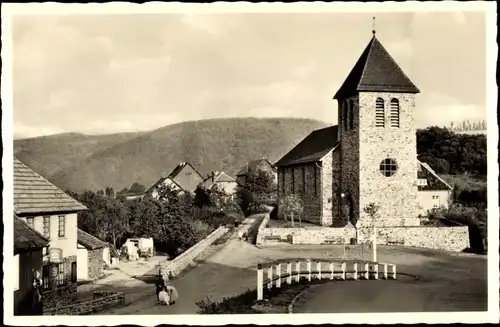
[14,158,87,307]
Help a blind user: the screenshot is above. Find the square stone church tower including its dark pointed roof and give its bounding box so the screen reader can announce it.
[334,31,419,227]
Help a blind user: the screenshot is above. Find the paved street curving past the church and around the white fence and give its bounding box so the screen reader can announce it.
[87,217,487,315]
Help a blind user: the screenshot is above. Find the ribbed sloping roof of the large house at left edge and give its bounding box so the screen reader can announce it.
[14,158,87,215]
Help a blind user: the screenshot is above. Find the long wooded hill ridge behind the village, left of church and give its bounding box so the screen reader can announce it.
[14,118,328,191]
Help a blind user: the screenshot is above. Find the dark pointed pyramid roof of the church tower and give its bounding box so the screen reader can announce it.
[334,36,420,99]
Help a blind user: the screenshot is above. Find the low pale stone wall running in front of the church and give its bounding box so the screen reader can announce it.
[257,226,470,252]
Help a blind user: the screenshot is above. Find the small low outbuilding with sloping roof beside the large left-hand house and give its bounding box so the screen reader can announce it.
[77,229,110,281]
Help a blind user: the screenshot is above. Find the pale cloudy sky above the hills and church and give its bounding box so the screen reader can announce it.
[12,12,486,138]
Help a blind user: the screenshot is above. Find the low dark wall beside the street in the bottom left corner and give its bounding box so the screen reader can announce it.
[43,292,125,316]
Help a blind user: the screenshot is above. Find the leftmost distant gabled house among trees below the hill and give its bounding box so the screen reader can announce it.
[145,162,204,198]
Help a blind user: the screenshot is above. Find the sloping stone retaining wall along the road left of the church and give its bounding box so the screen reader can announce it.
[160,226,229,277]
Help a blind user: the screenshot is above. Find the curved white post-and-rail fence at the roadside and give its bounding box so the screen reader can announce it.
[257,258,396,300]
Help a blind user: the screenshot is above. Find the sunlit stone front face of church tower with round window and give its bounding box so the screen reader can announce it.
[356,92,419,226]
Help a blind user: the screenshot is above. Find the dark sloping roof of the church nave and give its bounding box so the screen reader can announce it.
[276,125,339,167]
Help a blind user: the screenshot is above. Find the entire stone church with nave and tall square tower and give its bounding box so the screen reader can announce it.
[276,31,450,227]
